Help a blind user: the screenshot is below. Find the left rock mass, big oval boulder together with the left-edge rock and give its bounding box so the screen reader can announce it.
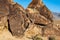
[0,0,29,36]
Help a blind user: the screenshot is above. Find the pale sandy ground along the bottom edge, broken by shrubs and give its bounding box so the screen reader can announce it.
[0,29,47,40]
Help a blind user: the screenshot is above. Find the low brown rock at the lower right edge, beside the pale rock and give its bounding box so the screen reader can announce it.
[42,25,60,37]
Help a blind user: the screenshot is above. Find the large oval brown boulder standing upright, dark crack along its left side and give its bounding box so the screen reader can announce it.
[8,3,28,36]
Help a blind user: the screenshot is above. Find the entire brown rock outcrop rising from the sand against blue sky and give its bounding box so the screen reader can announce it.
[0,0,60,40]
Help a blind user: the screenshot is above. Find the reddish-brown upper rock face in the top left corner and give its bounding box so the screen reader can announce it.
[0,0,9,17]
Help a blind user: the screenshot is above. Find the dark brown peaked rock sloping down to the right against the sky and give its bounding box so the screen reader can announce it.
[28,0,53,22]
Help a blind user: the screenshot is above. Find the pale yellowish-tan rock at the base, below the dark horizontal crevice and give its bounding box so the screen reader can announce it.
[25,24,42,38]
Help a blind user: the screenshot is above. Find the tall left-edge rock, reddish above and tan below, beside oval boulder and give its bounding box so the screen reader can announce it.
[0,0,9,30]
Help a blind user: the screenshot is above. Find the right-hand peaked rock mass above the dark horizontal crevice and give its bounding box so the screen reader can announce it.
[26,0,53,25]
